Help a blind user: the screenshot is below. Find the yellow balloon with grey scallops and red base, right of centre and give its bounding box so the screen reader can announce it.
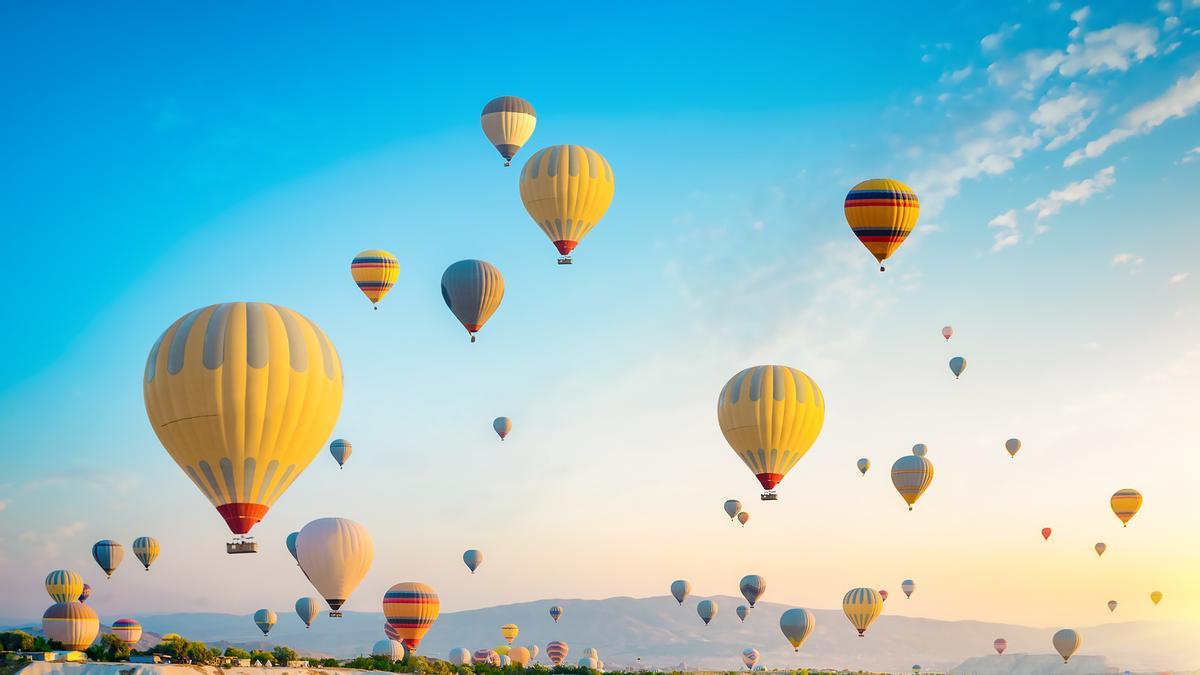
[716,365,824,500]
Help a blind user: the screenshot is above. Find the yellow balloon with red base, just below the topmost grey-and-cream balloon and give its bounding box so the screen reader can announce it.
[521,145,614,264]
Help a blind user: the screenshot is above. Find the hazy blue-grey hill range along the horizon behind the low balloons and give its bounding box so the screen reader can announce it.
[4,596,1200,675]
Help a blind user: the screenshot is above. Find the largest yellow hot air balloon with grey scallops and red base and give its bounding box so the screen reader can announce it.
[143,303,342,538]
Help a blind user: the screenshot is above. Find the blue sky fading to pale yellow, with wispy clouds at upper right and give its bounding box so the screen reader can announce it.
[0,0,1200,629]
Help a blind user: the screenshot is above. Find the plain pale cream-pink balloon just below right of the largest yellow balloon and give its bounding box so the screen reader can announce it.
[296,518,374,617]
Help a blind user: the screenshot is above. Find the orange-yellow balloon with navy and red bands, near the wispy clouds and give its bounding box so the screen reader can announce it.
[845,178,920,271]
